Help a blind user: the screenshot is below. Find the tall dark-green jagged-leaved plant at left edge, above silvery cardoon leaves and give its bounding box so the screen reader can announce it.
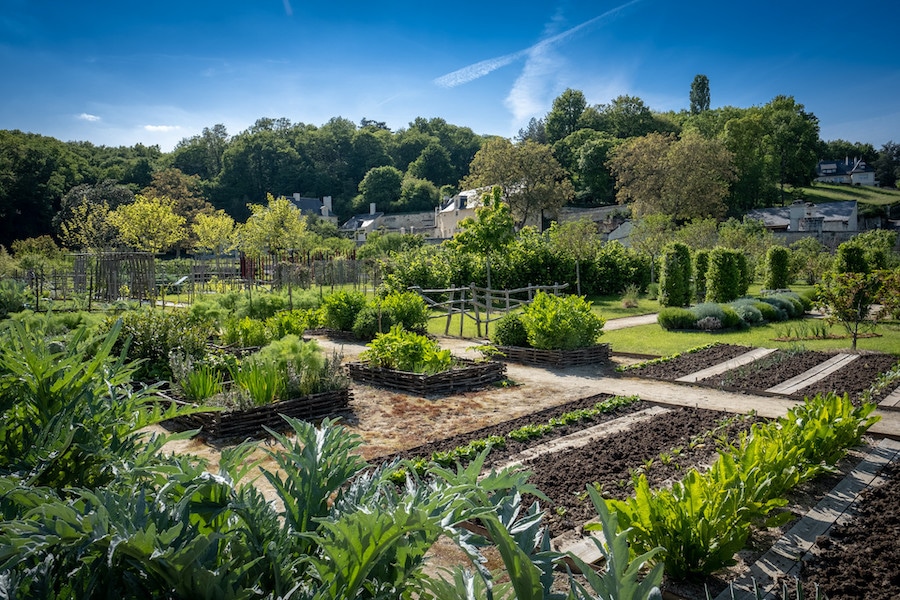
[0,322,188,489]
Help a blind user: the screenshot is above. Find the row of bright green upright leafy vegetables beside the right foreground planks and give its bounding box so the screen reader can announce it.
[607,394,878,579]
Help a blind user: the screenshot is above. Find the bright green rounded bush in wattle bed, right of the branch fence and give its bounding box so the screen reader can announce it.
[521,292,606,350]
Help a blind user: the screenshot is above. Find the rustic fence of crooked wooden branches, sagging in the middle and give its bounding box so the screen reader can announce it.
[409,283,569,337]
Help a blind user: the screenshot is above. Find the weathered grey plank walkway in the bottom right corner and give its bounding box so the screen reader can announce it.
[716,439,900,600]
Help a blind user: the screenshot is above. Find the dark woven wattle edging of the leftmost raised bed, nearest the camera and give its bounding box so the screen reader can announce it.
[165,388,353,439]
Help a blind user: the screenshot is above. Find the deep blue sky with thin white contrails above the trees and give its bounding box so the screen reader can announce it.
[0,0,900,151]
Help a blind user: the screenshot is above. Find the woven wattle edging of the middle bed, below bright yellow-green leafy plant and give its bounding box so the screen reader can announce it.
[346,359,506,396]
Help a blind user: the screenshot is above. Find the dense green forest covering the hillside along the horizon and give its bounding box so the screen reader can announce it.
[0,83,900,249]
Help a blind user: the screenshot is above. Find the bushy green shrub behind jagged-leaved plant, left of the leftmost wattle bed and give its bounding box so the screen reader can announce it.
[101,308,209,379]
